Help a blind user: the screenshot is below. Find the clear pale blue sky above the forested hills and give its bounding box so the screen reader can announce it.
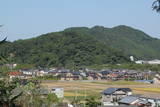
[0,0,160,41]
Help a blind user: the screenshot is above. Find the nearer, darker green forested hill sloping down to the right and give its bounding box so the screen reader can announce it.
[0,30,129,67]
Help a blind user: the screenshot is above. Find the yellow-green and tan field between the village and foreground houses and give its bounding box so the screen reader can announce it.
[42,81,160,98]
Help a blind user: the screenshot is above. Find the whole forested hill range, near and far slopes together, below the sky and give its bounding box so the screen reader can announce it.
[0,26,160,67]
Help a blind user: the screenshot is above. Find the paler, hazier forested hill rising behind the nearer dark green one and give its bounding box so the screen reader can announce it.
[66,25,160,60]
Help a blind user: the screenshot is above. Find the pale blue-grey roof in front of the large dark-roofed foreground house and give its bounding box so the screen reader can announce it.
[119,96,138,104]
